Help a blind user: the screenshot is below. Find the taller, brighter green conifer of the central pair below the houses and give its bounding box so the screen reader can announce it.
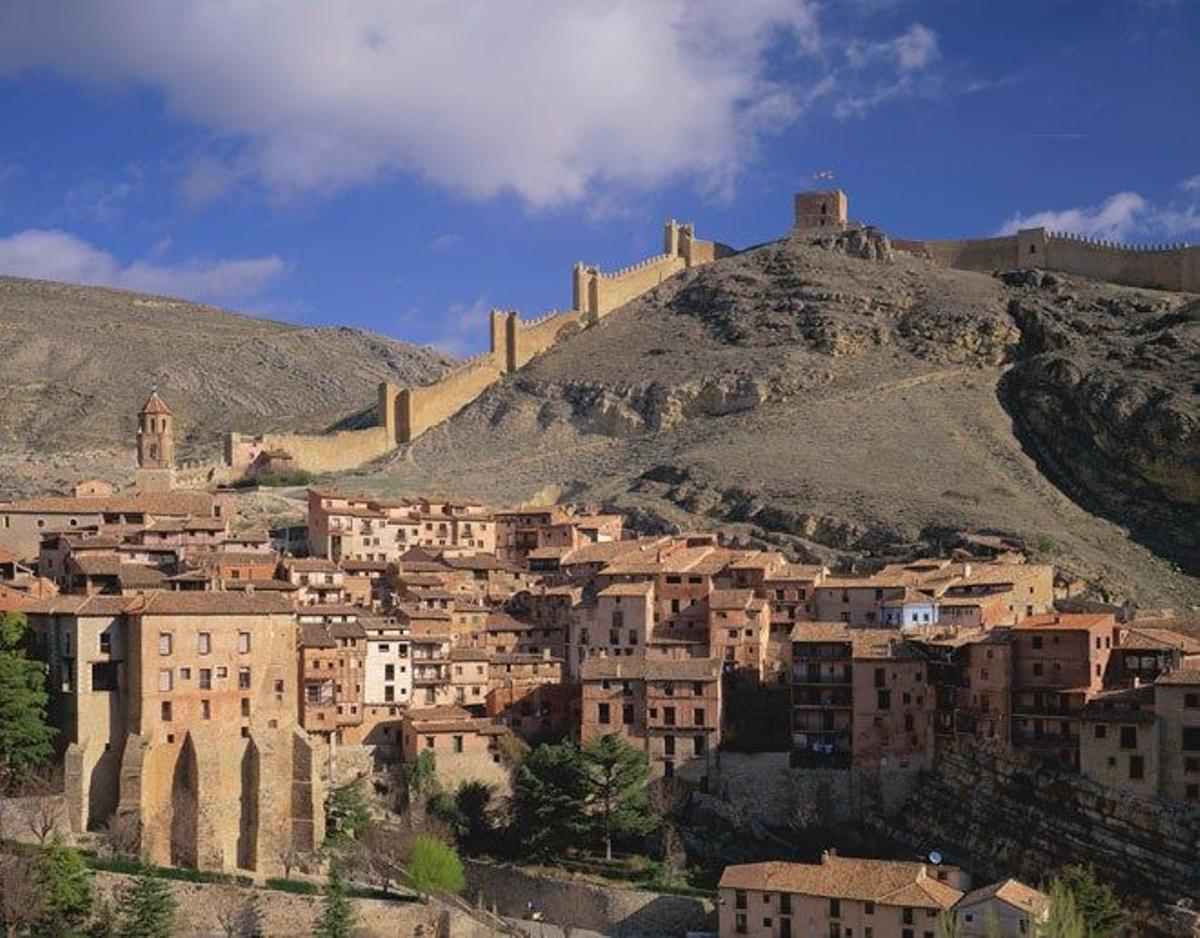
[582,733,655,860]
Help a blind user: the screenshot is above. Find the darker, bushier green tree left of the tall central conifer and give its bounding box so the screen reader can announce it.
[512,742,588,859]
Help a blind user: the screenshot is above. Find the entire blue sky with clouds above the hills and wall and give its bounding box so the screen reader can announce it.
[0,0,1200,354]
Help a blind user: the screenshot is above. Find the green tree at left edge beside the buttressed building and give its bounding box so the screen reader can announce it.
[0,613,54,782]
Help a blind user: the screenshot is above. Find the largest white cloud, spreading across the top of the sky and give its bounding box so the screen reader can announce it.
[0,0,937,208]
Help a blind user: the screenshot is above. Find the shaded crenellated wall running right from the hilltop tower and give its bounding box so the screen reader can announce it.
[892,228,1200,293]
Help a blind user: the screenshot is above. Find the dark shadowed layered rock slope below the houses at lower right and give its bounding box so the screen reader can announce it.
[880,747,1200,934]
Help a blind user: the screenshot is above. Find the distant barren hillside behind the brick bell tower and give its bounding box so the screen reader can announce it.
[0,277,450,495]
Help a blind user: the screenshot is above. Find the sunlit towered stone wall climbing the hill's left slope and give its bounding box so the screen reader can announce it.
[226,221,733,476]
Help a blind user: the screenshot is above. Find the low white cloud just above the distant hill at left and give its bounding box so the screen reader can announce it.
[0,228,287,300]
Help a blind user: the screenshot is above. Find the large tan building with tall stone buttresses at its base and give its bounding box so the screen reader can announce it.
[29,593,324,870]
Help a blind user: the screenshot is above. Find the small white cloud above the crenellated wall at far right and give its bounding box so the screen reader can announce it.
[997,176,1200,241]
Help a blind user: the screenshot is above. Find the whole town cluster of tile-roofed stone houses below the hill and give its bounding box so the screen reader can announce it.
[0,398,1200,938]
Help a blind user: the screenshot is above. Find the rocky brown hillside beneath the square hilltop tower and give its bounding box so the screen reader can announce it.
[367,231,1200,602]
